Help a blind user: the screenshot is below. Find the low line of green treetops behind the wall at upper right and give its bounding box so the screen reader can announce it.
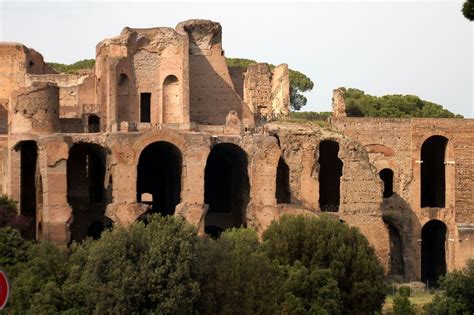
[341,88,462,118]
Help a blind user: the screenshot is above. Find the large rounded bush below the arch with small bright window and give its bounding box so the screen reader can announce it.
[78,215,199,314]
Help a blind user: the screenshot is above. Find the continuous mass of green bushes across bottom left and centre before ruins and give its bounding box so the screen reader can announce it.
[0,216,385,314]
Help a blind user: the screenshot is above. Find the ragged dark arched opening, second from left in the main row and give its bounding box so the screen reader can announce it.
[67,143,110,241]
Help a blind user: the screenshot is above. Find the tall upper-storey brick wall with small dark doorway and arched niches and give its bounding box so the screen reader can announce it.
[95,27,189,129]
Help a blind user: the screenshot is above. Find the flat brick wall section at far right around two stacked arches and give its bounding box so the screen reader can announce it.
[333,117,474,277]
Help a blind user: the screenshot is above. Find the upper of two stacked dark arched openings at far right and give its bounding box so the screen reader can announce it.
[421,136,448,208]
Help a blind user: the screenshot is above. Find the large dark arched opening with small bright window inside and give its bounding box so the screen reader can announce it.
[137,141,183,215]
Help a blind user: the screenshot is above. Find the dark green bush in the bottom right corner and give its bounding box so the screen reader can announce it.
[426,259,474,315]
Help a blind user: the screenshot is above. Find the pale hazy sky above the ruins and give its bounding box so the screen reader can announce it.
[0,0,474,118]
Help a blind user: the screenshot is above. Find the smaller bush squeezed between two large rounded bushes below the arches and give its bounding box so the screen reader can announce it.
[197,229,283,314]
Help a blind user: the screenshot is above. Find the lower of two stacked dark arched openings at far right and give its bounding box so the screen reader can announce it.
[421,220,447,286]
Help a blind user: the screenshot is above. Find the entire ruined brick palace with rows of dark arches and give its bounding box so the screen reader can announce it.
[0,20,474,281]
